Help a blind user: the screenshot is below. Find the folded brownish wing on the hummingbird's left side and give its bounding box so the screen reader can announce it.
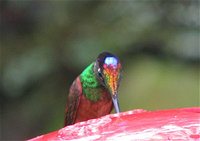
[65,77,82,126]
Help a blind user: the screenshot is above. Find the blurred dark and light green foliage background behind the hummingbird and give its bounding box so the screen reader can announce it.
[0,0,200,140]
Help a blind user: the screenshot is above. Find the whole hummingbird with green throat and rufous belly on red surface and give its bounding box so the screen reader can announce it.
[64,52,122,126]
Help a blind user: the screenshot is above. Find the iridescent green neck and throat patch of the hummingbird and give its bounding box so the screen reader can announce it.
[80,63,103,102]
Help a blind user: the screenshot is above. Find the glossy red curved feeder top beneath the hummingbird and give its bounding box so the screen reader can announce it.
[29,107,200,141]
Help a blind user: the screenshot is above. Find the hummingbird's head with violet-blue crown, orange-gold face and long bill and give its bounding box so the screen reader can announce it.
[94,52,122,113]
